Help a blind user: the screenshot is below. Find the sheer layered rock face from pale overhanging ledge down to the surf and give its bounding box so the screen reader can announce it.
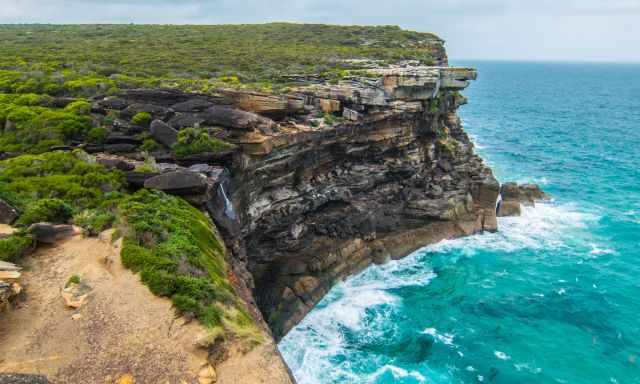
[198,67,500,338]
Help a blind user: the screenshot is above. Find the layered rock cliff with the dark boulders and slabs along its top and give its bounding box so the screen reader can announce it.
[86,55,500,339]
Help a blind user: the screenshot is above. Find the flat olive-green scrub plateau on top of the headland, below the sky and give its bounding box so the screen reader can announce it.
[0,23,439,96]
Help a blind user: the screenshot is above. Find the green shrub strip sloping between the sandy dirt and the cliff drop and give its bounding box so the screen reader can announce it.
[117,190,259,339]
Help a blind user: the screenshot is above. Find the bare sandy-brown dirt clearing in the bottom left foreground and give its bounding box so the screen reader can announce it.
[0,231,207,384]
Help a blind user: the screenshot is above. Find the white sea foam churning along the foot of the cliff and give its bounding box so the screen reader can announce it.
[279,202,605,384]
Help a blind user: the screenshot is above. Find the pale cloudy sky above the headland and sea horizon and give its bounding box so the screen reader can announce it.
[0,0,640,62]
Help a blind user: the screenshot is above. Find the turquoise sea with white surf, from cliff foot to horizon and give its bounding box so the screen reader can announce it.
[279,62,640,384]
